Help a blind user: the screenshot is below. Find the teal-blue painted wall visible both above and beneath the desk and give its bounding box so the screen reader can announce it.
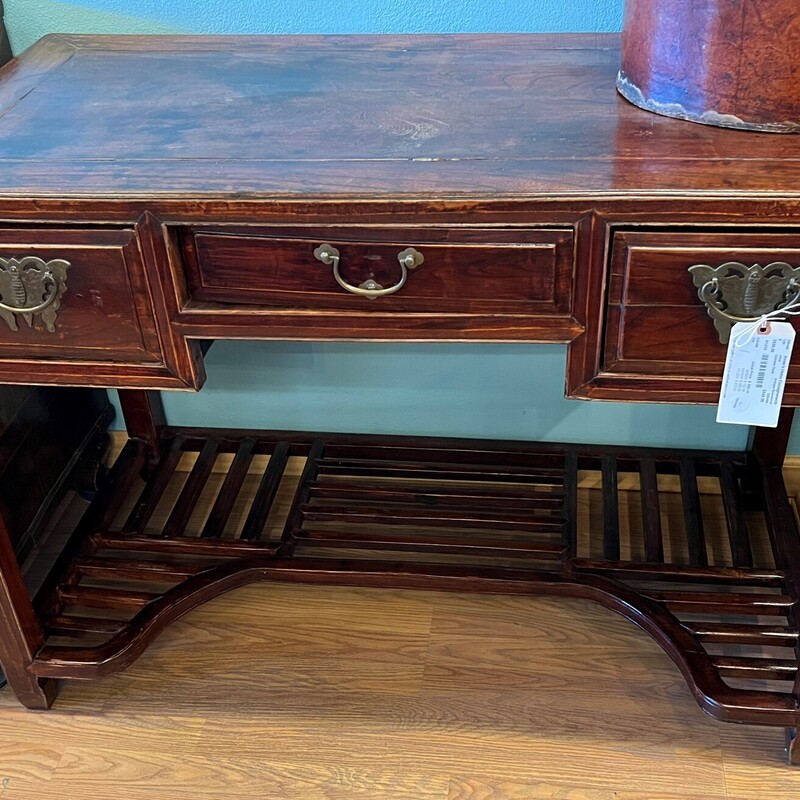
[0,0,764,448]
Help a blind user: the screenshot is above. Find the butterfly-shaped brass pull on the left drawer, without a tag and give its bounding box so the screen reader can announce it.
[0,256,70,333]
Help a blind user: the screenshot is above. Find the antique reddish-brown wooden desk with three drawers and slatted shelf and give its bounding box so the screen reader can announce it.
[0,36,800,764]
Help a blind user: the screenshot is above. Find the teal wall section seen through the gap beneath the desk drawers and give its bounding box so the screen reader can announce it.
[147,342,745,448]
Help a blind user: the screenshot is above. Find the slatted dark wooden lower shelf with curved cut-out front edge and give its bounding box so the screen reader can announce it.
[25,430,800,756]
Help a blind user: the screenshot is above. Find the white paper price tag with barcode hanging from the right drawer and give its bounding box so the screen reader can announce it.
[717,321,795,428]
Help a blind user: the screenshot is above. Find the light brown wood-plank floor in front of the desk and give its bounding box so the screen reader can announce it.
[0,460,800,800]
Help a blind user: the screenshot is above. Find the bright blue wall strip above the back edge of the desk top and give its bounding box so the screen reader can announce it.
[6,0,623,49]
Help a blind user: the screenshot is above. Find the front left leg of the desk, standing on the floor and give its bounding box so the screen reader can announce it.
[0,517,58,710]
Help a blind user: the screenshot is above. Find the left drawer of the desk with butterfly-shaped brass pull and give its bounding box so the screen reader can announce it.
[0,227,202,388]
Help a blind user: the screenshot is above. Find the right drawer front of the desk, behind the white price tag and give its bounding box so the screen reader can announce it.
[570,230,800,405]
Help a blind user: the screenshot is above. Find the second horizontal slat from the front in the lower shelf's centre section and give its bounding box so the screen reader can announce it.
[300,505,562,533]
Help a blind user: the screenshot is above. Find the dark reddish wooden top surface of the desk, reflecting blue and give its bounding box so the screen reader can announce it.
[0,35,800,198]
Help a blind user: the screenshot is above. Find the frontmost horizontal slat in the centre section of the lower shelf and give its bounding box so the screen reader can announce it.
[294,530,564,557]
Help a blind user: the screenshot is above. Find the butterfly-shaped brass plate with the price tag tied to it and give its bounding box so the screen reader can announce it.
[689,261,800,344]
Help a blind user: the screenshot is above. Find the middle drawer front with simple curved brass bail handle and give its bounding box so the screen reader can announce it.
[173,227,574,338]
